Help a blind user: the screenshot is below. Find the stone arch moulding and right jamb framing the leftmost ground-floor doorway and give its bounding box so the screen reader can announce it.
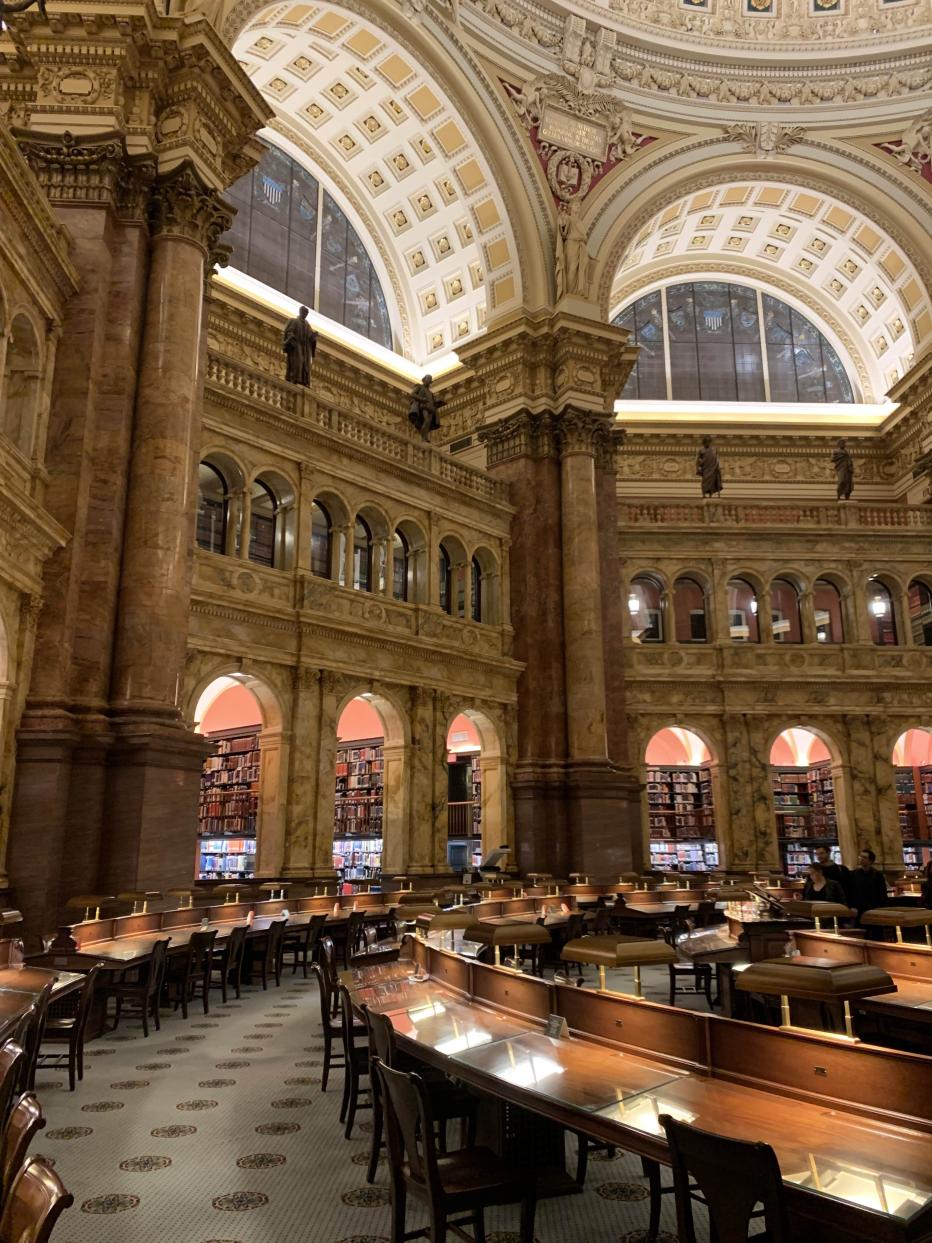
[188,661,291,876]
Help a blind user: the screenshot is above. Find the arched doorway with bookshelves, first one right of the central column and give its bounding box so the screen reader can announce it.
[644,726,718,871]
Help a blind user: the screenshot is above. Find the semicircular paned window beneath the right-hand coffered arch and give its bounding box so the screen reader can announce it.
[613,281,855,404]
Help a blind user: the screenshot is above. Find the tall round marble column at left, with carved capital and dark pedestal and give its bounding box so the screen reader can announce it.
[103,164,230,888]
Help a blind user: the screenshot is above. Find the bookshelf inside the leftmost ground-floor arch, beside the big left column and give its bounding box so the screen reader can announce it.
[198,726,262,880]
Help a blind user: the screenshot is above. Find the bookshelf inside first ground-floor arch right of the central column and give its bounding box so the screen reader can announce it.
[647,764,718,871]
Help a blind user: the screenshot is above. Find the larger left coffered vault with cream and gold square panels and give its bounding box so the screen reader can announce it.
[234,4,522,364]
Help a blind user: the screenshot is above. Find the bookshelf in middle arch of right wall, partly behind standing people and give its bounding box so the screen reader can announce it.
[772,759,841,876]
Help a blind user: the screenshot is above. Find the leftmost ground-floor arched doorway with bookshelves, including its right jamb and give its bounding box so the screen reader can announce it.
[194,672,287,880]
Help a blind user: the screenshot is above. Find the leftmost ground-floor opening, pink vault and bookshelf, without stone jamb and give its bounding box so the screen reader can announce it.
[194,675,266,880]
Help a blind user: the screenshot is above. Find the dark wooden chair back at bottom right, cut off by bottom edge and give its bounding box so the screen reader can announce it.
[660,1114,790,1243]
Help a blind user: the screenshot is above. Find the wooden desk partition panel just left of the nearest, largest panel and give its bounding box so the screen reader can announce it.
[554,984,708,1070]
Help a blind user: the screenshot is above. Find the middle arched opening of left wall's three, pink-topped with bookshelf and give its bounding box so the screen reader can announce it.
[333,695,385,892]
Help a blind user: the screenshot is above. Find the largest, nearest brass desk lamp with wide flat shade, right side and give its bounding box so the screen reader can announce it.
[734,955,896,1043]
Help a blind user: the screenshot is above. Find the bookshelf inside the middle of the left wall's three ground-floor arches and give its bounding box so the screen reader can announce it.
[333,738,385,881]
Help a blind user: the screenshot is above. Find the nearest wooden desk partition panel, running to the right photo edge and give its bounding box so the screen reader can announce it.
[707,1016,932,1132]
